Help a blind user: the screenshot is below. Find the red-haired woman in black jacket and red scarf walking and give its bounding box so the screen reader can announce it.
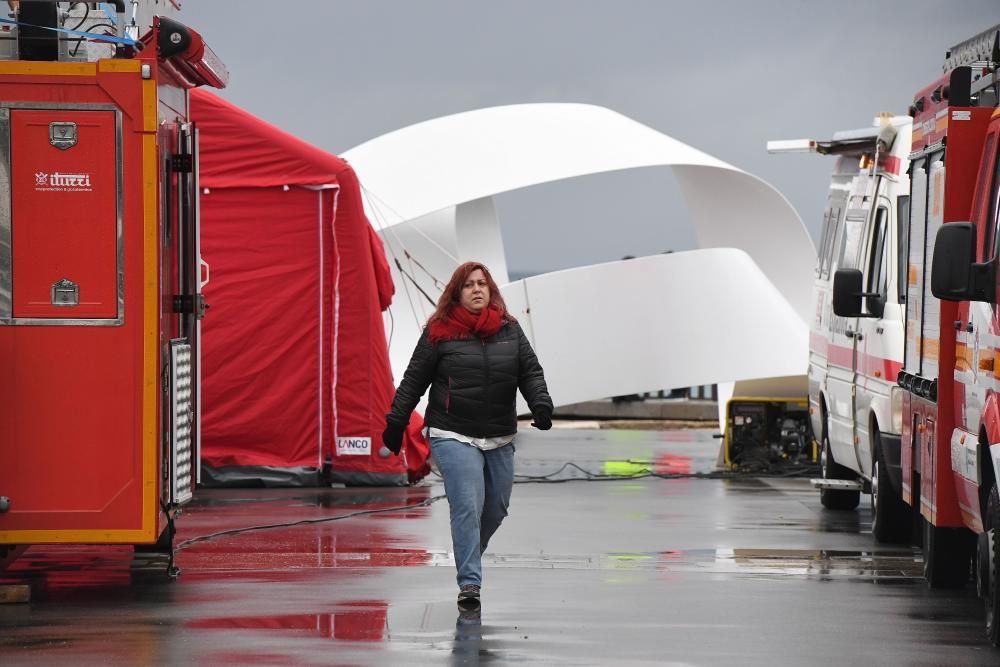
[382,262,552,604]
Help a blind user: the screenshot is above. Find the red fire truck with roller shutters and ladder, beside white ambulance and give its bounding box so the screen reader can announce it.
[834,26,1000,645]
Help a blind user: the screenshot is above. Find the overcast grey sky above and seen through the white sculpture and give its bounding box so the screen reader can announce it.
[179,0,1000,273]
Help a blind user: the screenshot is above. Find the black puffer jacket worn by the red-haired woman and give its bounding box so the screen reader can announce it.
[386,322,552,438]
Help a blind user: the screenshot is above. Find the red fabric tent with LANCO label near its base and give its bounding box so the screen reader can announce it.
[191,89,427,485]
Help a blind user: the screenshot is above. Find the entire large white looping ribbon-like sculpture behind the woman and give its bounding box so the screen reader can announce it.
[343,104,815,404]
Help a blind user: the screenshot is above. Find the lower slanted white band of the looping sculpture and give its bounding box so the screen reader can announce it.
[502,248,809,404]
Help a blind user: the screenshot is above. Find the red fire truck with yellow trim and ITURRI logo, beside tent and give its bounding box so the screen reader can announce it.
[0,2,228,576]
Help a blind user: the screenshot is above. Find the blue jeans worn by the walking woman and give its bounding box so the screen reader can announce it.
[431,438,514,587]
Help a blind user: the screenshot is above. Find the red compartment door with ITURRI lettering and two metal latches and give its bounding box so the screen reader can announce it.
[9,109,120,324]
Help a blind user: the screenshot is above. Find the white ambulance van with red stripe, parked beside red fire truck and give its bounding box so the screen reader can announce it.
[768,114,912,541]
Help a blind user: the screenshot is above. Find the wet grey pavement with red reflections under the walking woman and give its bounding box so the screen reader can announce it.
[0,429,1000,665]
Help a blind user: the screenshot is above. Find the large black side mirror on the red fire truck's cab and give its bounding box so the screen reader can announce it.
[931,222,996,302]
